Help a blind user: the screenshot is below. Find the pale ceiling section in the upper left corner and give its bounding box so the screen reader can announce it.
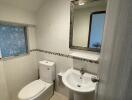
[0,0,45,12]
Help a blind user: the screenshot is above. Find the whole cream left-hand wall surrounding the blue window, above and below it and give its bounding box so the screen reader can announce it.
[0,4,38,100]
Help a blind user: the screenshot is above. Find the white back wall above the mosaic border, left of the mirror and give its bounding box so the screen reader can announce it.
[37,0,70,53]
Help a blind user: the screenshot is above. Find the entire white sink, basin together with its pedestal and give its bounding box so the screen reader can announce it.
[62,69,96,100]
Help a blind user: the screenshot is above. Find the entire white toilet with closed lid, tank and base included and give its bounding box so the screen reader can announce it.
[18,60,55,100]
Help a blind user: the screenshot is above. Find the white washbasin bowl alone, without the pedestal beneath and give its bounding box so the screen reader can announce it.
[62,69,96,93]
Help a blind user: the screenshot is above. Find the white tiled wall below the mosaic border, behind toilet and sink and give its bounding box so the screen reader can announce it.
[37,50,98,96]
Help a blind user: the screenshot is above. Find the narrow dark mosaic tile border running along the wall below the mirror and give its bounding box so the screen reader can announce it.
[30,49,99,64]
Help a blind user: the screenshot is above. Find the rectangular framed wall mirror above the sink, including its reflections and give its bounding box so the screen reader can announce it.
[69,0,107,52]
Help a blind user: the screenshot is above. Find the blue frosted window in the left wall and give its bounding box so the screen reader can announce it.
[0,24,28,58]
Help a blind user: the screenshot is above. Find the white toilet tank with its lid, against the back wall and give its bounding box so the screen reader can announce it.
[39,60,55,83]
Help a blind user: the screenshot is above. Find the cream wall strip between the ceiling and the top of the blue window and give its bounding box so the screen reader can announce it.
[0,3,36,25]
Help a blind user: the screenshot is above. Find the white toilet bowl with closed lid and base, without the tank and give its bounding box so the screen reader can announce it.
[18,80,53,100]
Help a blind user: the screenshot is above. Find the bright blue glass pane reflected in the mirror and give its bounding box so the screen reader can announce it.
[89,13,105,48]
